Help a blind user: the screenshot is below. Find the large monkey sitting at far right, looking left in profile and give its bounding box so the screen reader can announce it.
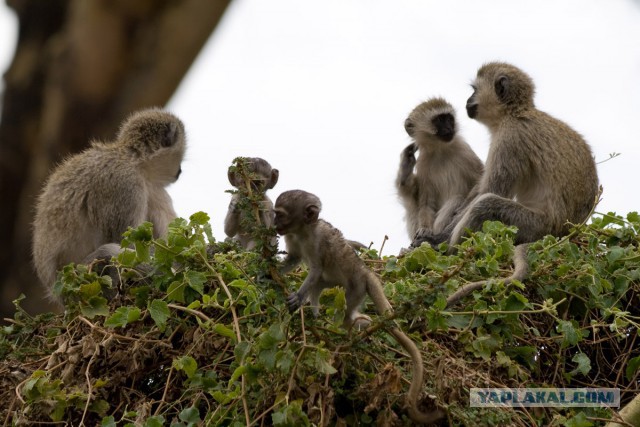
[417,62,598,251]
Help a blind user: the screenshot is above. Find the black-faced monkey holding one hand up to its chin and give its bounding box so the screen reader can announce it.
[396,98,483,244]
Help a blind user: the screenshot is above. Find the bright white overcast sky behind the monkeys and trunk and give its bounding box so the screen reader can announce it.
[0,0,640,255]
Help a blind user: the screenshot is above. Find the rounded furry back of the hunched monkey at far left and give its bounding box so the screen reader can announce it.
[33,145,146,284]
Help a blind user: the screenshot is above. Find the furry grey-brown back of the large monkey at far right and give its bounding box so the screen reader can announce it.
[487,110,598,234]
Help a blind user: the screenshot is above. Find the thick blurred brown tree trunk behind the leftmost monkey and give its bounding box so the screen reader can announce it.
[0,0,229,317]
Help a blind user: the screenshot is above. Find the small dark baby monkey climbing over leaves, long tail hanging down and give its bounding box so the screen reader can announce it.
[275,190,443,423]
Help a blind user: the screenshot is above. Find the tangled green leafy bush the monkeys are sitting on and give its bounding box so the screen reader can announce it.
[0,213,640,426]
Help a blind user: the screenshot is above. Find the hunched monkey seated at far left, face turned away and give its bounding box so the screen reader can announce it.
[33,108,186,302]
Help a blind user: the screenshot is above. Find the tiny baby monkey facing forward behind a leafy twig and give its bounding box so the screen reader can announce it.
[224,157,280,250]
